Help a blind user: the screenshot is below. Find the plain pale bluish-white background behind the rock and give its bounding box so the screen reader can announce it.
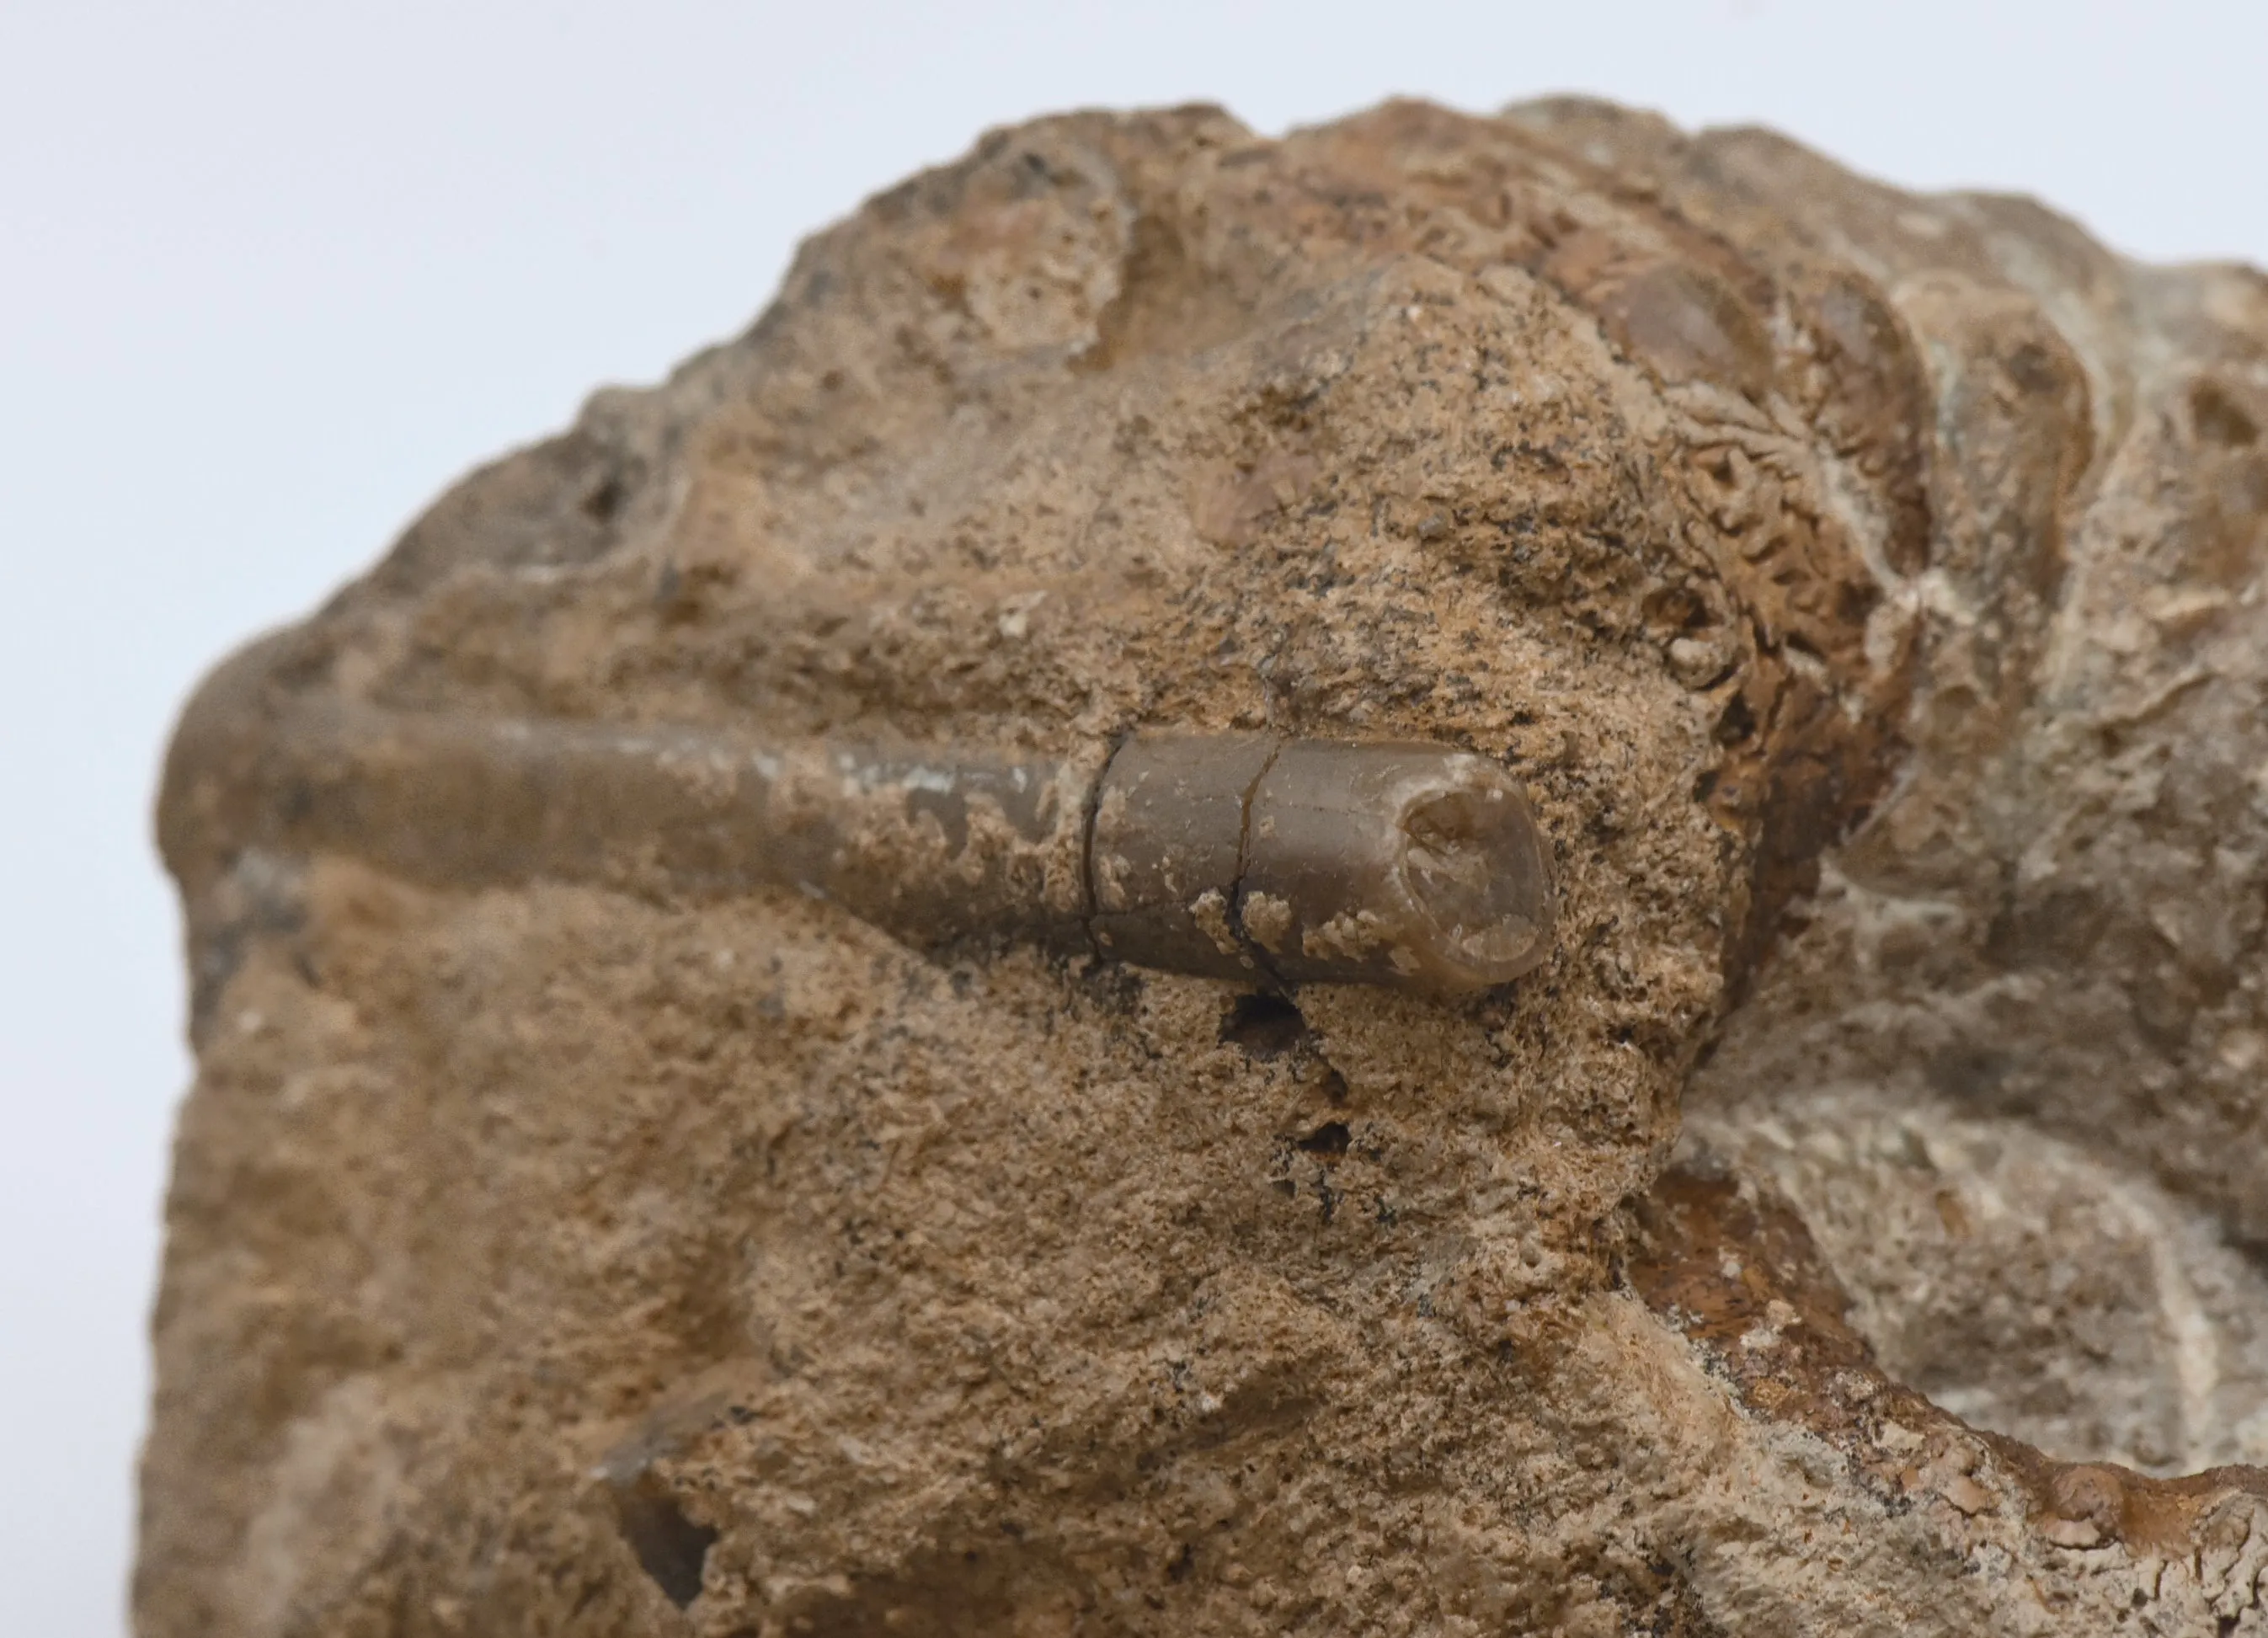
[0,0,2268,1638]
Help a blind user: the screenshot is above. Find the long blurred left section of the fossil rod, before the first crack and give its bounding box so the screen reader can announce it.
[159,644,1102,948]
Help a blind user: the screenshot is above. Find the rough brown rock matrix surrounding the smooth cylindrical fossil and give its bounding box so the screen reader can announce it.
[136,102,2268,1638]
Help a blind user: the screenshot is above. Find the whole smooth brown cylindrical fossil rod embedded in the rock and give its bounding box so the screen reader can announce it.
[168,680,1554,994]
